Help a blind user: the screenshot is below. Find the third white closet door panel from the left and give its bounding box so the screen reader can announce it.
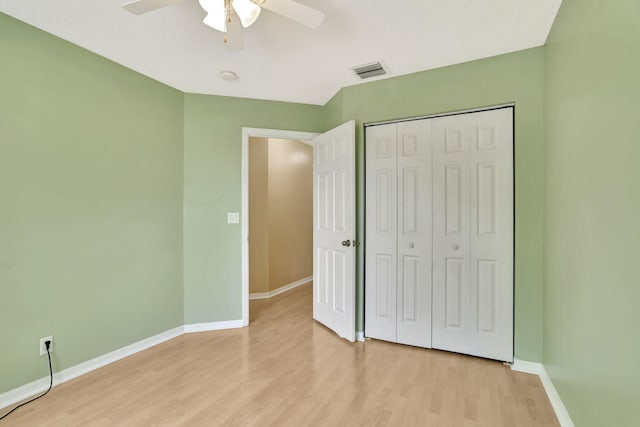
[432,115,472,353]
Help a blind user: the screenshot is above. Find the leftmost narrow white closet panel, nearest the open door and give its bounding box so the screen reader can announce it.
[365,124,398,342]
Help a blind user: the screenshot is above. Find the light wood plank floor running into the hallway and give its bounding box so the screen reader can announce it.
[0,285,558,427]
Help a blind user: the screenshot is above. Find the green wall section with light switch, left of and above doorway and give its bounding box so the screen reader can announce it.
[184,94,325,323]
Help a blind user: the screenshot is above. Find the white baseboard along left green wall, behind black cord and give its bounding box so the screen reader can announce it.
[0,326,184,408]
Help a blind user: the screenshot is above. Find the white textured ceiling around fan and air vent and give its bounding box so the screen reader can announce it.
[0,0,561,104]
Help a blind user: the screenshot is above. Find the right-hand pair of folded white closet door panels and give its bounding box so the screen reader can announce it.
[432,108,513,361]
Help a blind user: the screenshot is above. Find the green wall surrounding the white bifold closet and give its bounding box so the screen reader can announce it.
[327,48,544,362]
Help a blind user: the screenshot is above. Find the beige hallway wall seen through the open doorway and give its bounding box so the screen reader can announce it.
[249,137,313,293]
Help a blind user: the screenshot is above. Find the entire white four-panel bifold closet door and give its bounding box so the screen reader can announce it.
[365,108,513,361]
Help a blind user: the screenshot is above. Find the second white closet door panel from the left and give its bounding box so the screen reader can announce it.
[397,120,431,347]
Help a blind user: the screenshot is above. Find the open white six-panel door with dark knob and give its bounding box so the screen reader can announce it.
[313,120,356,341]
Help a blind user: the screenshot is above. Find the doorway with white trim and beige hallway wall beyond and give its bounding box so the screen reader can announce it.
[241,128,317,326]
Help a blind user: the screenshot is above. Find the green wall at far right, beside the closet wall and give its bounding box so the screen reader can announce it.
[544,0,640,427]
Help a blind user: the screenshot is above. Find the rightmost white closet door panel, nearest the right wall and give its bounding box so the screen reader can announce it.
[469,108,514,361]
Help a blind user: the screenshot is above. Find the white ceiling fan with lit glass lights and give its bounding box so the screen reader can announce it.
[122,0,324,50]
